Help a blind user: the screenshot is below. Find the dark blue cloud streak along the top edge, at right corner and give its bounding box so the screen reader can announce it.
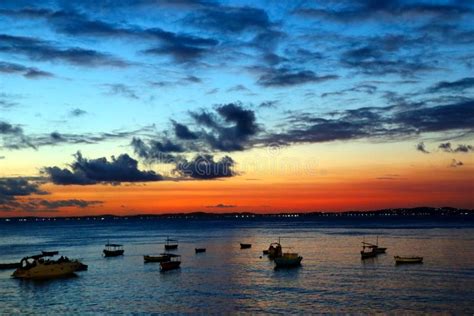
[296,0,472,23]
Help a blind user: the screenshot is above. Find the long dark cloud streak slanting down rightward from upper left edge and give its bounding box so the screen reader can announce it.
[0,34,128,67]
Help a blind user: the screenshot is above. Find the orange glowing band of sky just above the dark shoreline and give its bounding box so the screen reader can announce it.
[3,160,474,216]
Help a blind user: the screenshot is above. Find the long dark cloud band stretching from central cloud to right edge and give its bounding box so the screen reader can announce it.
[256,100,474,149]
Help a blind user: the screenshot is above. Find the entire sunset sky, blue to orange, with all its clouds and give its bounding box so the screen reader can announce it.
[0,0,474,217]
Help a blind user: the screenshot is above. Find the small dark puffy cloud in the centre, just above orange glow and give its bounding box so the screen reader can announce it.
[174,155,236,180]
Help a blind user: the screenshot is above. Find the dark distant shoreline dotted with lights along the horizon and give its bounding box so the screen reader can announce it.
[0,207,474,222]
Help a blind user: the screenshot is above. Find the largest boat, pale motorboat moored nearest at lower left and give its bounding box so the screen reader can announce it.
[12,255,82,279]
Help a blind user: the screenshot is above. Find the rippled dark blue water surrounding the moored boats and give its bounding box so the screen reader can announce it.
[0,218,474,314]
